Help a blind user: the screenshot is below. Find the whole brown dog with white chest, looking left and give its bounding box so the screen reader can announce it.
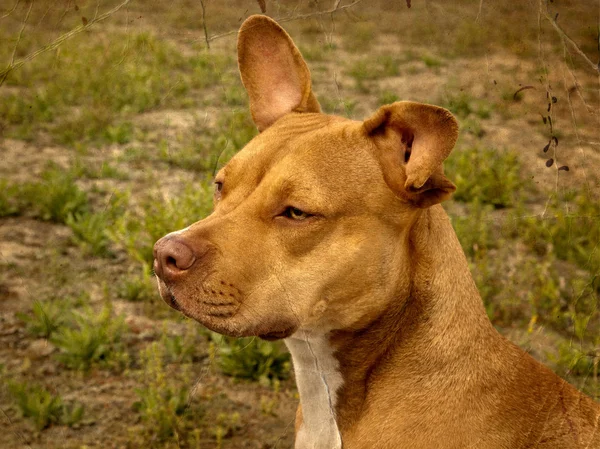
[155,16,600,449]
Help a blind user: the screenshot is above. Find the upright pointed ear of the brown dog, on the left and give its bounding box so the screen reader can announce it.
[238,15,321,131]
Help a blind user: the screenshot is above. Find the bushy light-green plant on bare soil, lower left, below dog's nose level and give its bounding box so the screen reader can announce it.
[51,302,127,372]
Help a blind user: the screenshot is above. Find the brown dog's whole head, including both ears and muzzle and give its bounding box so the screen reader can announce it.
[154,16,457,339]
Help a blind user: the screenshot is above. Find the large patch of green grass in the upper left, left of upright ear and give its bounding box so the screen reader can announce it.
[0,33,233,146]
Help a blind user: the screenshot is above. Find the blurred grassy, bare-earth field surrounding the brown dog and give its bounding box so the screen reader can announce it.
[0,0,600,449]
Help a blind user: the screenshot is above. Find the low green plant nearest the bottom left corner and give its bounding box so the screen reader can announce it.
[8,381,84,431]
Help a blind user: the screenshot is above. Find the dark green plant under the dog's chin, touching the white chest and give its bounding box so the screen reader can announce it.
[211,333,291,383]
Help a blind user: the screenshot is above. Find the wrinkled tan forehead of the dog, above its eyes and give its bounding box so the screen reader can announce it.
[223,114,382,200]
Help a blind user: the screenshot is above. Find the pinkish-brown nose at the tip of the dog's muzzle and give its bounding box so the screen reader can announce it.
[154,235,196,280]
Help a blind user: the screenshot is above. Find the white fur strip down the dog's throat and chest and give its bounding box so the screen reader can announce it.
[285,331,343,449]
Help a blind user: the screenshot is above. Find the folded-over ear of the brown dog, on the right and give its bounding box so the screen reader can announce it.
[363,101,458,208]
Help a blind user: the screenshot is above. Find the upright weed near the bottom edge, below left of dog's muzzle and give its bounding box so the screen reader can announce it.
[134,342,195,441]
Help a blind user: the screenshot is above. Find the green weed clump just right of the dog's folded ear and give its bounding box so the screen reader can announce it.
[445,147,523,208]
